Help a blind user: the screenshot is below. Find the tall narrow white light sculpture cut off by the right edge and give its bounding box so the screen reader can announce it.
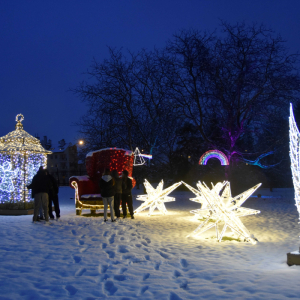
[289,104,300,219]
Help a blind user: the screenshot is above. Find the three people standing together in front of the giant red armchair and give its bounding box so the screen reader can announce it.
[99,169,134,222]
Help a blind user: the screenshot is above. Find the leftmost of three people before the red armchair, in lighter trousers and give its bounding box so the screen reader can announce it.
[99,169,116,222]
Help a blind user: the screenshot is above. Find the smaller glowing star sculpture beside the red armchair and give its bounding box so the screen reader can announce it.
[134,179,181,216]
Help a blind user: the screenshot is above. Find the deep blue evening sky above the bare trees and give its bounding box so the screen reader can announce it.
[0,0,300,143]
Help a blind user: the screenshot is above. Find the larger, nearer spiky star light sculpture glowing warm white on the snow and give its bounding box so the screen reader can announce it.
[183,181,261,244]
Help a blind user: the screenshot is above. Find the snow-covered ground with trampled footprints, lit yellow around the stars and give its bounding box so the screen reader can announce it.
[0,187,300,300]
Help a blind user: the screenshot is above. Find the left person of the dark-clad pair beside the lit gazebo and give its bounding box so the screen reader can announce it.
[27,167,52,222]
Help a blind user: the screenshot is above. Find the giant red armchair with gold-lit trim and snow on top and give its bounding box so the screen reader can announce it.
[69,148,135,215]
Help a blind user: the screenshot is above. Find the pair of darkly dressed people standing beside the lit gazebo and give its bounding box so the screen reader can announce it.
[27,166,60,222]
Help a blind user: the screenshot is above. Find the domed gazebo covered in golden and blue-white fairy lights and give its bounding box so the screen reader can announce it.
[0,114,52,203]
